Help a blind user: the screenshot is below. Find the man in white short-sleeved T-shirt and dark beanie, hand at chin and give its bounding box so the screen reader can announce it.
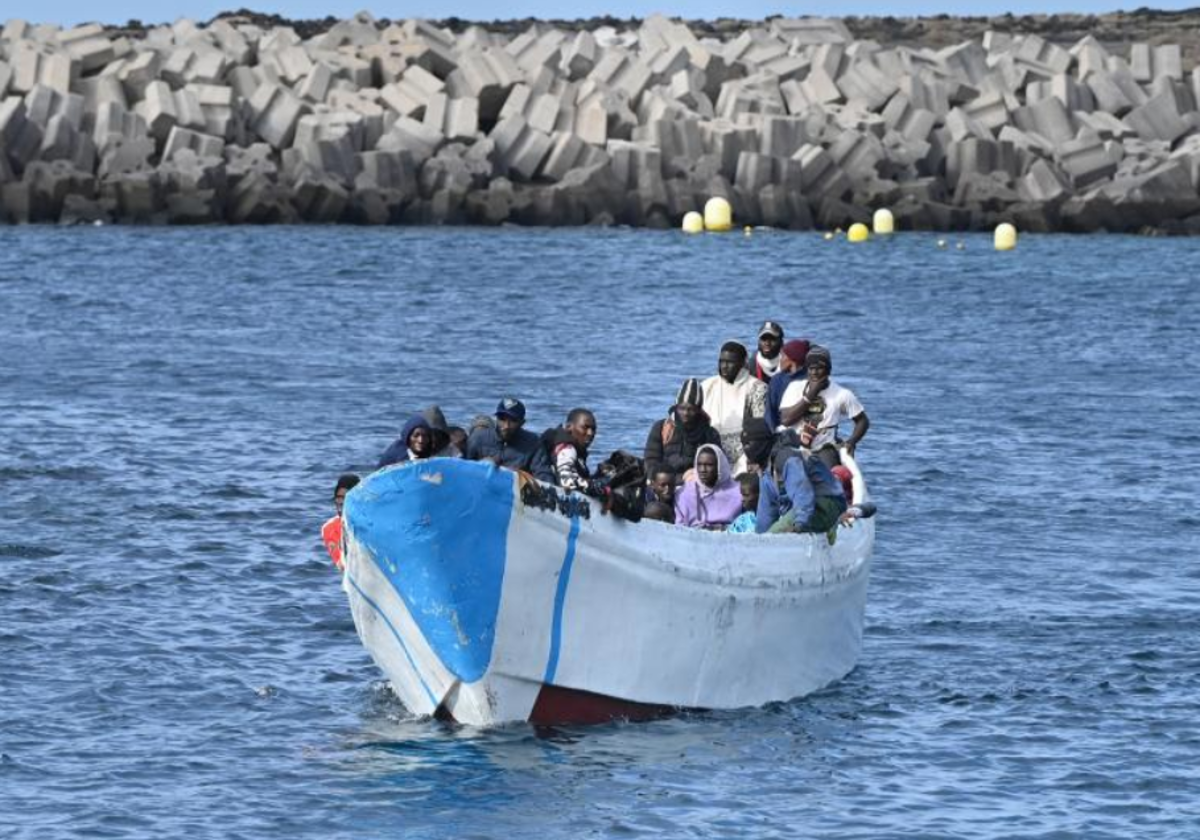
[780,347,871,467]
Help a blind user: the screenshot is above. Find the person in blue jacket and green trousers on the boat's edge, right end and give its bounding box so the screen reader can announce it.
[755,419,846,534]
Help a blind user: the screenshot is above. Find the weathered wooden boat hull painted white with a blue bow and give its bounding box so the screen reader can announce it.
[343,457,875,725]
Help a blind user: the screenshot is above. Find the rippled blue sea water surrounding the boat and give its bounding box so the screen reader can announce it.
[0,227,1200,840]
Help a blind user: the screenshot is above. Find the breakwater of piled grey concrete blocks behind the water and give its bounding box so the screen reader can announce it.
[0,13,1200,233]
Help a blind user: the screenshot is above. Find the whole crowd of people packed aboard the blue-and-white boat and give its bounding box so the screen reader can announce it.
[322,320,875,565]
